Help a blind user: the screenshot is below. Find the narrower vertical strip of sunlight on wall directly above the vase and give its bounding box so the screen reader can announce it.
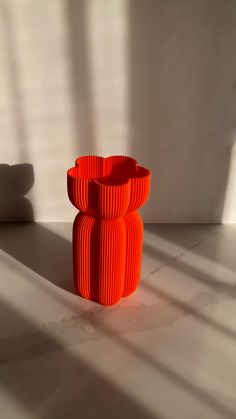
[86,0,128,155]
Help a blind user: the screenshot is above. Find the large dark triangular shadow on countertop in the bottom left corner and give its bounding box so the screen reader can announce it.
[0,298,161,419]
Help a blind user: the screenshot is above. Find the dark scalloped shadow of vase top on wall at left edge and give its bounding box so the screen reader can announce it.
[0,163,34,221]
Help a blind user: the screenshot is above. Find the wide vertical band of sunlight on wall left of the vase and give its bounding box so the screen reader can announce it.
[4,0,74,220]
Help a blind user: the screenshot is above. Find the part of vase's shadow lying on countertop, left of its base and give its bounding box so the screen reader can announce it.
[0,223,75,293]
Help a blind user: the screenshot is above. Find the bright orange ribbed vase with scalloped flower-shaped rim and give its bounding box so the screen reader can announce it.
[67,156,151,305]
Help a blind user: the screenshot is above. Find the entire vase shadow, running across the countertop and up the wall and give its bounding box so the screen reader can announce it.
[0,163,73,292]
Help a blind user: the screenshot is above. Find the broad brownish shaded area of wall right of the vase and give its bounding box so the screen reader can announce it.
[128,0,236,222]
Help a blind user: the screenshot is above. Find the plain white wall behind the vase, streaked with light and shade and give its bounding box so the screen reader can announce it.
[0,0,236,222]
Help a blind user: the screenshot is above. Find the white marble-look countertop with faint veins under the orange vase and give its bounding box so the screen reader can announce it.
[0,223,236,419]
